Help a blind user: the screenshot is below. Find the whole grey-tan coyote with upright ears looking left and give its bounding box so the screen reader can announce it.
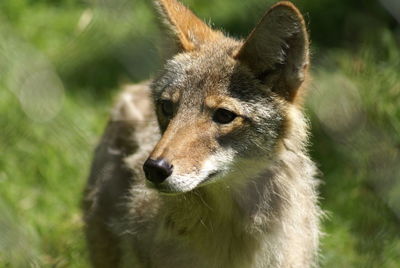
[83,0,321,268]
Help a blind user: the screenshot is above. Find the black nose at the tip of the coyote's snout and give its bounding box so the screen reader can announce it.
[143,158,173,184]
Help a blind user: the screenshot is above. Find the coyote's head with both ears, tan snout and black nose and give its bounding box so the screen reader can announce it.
[144,0,309,193]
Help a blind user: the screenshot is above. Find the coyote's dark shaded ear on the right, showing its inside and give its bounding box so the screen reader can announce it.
[235,2,309,101]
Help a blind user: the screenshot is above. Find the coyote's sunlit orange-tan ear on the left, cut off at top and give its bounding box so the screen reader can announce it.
[155,0,222,51]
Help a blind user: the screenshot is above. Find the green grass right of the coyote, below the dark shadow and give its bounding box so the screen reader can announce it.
[309,35,400,268]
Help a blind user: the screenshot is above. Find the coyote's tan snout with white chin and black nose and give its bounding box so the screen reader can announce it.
[143,98,236,193]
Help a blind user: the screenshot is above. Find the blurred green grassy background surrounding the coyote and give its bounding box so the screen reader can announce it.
[0,0,400,267]
